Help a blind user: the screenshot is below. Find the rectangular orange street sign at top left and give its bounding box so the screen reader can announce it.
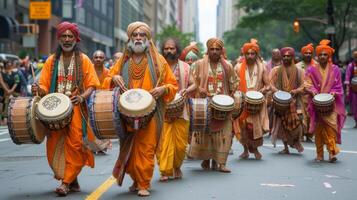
[30,1,51,19]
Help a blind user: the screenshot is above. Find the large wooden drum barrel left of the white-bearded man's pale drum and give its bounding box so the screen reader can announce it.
[87,88,123,139]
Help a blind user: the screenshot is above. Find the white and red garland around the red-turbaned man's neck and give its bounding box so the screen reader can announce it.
[57,54,75,95]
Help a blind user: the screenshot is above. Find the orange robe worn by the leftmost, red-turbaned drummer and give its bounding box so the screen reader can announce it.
[39,54,99,184]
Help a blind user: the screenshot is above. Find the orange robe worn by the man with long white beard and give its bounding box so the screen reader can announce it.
[103,56,177,189]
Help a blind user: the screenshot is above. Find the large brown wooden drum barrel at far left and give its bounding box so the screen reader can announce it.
[7,96,49,144]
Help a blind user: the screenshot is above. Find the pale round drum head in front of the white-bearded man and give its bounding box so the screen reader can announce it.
[119,89,156,116]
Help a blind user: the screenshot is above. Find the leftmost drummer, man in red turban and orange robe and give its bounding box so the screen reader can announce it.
[32,22,99,196]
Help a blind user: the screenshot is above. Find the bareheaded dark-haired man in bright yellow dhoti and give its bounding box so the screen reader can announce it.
[157,38,196,181]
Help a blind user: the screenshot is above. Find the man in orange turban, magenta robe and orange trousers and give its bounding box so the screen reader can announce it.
[304,39,346,163]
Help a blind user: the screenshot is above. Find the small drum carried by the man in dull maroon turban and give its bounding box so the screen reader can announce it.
[273,90,292,115]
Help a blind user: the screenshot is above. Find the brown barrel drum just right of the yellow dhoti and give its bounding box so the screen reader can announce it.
[189,98,211,132]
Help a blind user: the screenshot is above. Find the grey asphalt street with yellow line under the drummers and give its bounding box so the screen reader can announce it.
[0,117,357,200]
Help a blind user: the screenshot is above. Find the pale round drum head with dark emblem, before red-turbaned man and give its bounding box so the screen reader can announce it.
[37,93,72,120]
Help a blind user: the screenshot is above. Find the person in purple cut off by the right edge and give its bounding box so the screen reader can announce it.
[345,51,357,128]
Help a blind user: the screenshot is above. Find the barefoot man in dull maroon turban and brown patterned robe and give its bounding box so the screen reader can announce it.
[270,47,304,154]
